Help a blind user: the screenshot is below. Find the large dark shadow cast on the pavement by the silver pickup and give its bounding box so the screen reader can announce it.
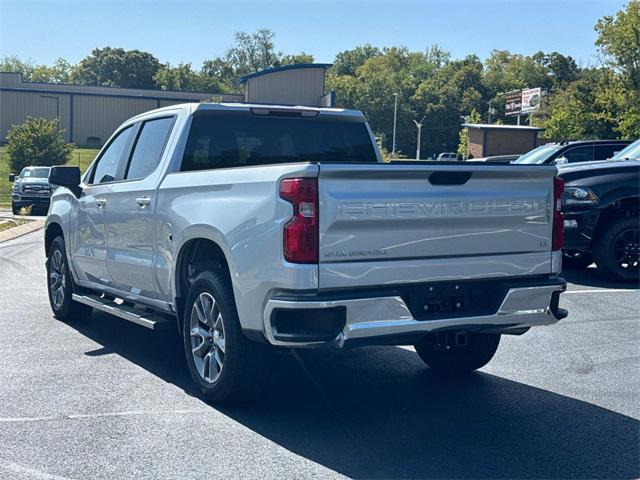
[73,314,640,478]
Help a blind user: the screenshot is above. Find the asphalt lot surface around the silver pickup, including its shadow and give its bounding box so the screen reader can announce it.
[0,231,640,479]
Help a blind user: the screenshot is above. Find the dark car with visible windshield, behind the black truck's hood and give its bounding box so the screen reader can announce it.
[511,140,631,165]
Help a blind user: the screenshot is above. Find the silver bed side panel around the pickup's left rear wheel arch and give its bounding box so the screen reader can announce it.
[155,164,318,330]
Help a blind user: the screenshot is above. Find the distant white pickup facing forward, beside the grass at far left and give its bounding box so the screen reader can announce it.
[9,167,52,215]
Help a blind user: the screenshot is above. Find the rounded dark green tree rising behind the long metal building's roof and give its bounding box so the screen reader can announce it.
[72,47,161,88]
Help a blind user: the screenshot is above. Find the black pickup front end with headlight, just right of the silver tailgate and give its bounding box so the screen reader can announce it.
[560,156,640,282]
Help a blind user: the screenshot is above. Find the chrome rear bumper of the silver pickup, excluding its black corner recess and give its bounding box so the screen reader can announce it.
[264,279,566,347]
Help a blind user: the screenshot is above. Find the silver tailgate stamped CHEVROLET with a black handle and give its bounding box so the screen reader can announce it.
[318,163,557,289]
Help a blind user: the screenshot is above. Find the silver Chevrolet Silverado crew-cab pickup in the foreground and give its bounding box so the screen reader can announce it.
[45,103,567,401]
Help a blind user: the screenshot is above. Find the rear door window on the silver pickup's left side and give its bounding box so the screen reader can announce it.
[125,117,174,180]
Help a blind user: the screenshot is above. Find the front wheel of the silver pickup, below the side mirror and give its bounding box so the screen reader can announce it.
[46,237,93,322]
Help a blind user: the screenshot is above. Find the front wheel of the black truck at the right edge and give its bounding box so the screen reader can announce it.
[593,217,640,282]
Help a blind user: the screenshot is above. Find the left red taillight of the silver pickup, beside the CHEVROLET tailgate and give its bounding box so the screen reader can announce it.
[280,178,318,263]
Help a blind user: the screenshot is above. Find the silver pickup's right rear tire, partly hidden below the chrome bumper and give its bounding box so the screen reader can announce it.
[415,332,500,373]
